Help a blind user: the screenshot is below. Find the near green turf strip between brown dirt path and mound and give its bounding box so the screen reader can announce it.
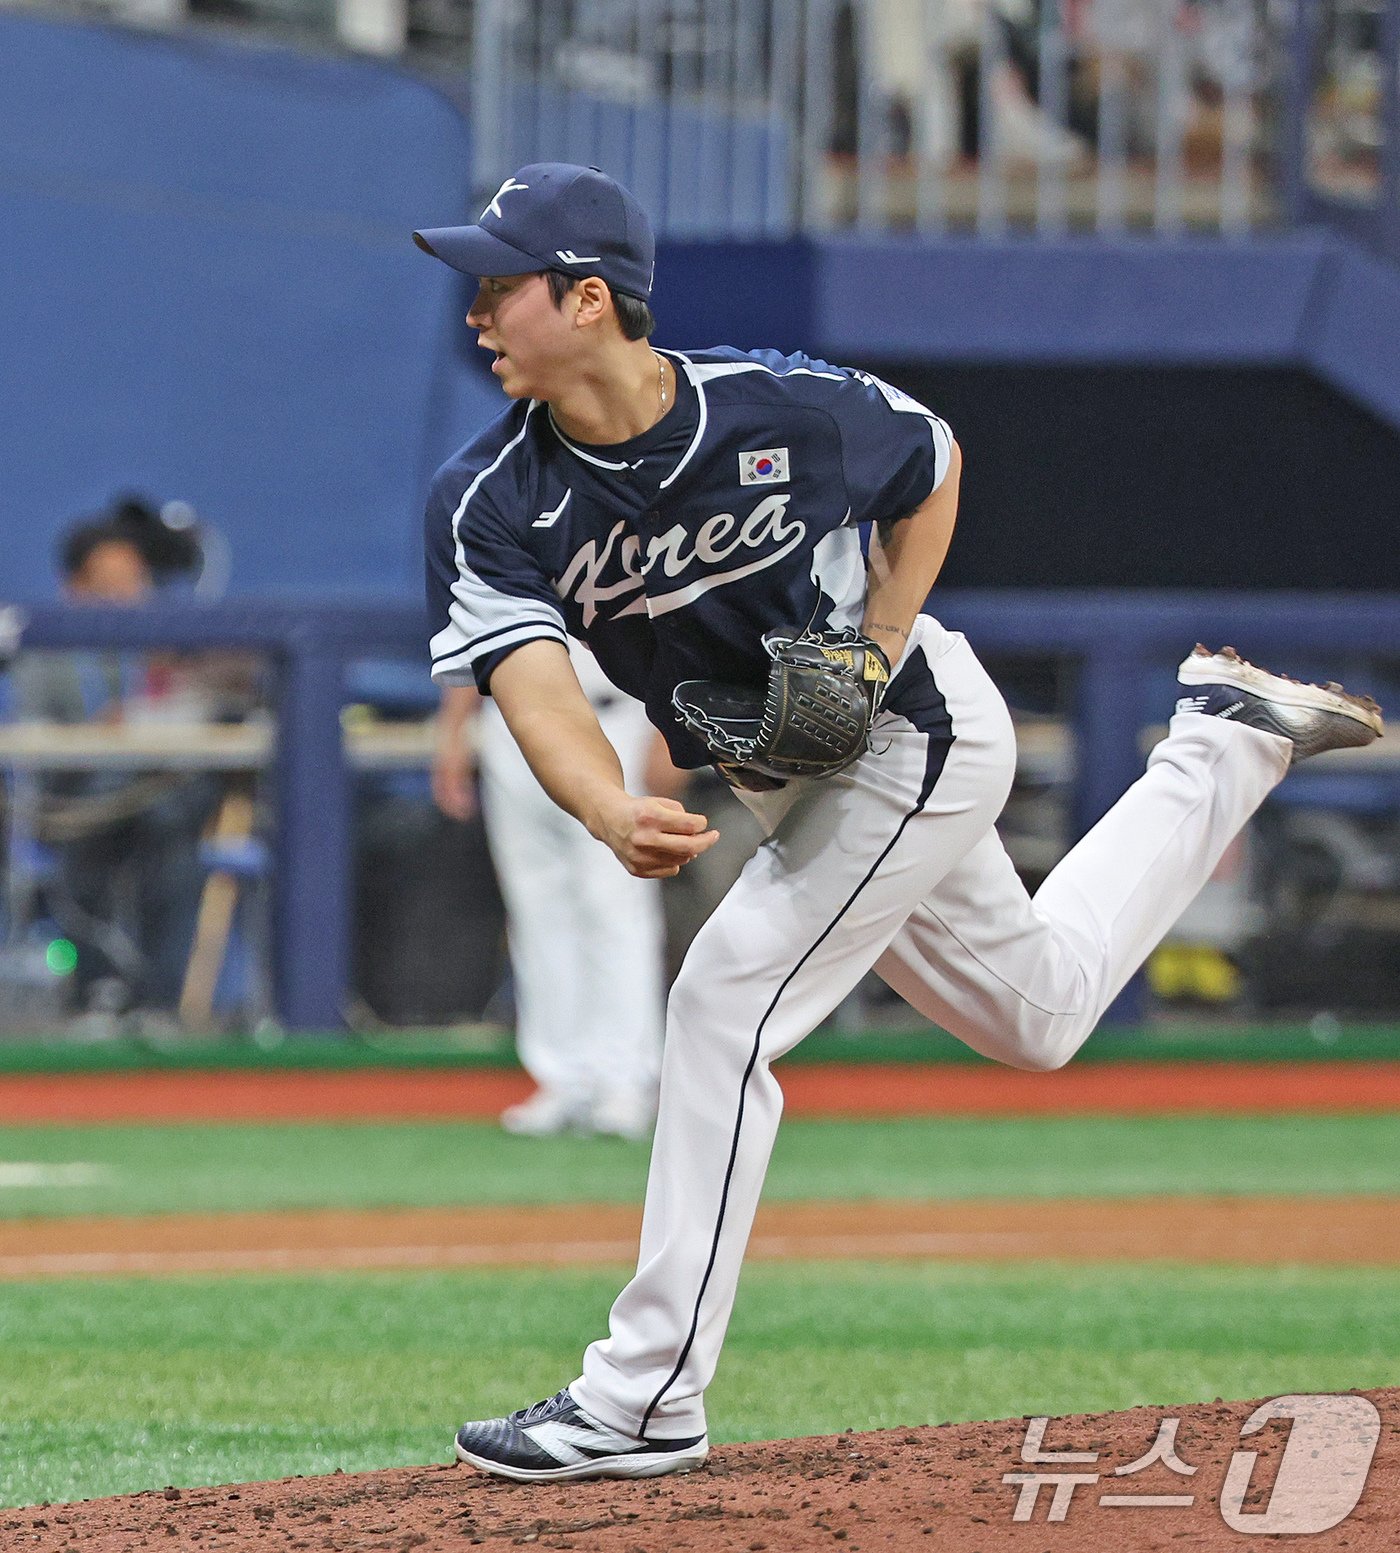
[0,1263,1400,1505]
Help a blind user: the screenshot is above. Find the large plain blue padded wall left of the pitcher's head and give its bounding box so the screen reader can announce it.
[0,14,491,598]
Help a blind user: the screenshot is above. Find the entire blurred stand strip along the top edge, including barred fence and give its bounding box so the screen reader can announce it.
[16,0,1400,255]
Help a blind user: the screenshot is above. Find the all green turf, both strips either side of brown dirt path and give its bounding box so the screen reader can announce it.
[0,1117,1400,1505]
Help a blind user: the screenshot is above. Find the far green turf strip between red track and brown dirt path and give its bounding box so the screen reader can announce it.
[0,1115,1400,1221]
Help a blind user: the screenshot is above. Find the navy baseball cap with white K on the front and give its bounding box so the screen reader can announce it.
[413,162,656,301]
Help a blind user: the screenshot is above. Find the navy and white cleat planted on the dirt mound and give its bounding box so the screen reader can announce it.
[457,1387,710,1483]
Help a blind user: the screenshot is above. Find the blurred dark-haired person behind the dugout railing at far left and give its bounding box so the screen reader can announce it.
[14,512,219,1037]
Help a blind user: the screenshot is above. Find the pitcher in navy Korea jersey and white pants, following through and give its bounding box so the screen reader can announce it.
[415,163,1381,1482]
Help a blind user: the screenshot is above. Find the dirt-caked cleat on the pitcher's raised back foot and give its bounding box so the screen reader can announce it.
[1176,643,1384,766]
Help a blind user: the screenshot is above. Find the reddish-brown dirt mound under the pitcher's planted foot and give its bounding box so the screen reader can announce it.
[13,1388,1400,1553]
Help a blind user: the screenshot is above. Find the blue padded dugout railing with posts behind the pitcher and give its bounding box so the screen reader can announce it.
[5,590,1400,1031]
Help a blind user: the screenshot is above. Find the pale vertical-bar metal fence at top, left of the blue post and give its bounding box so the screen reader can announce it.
[463,0,1286,236]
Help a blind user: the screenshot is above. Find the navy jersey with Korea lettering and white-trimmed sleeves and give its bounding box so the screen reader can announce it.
[426,348,952,767]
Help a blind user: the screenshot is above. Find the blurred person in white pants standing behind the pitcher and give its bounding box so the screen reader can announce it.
[432,646,676,1138]
